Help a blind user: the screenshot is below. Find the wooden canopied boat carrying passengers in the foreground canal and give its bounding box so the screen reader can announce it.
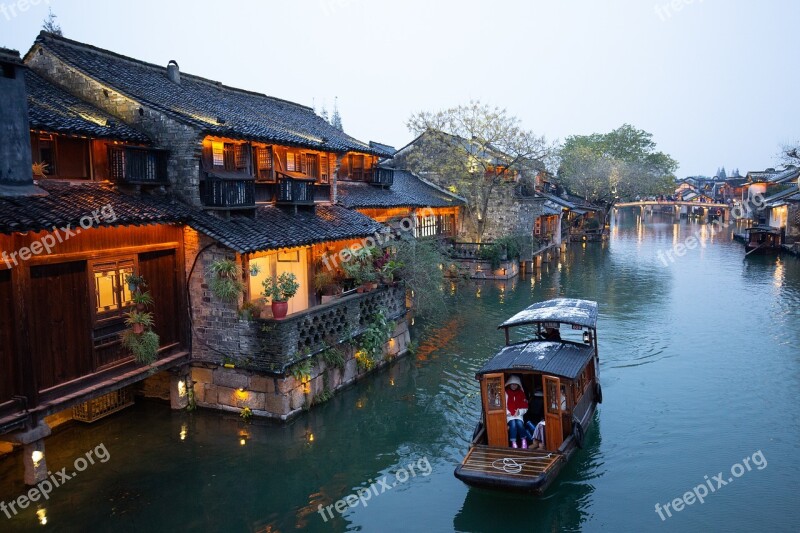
[455,298,602,494]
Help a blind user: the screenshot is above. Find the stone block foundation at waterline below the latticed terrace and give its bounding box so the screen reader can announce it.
[192,319,410,420]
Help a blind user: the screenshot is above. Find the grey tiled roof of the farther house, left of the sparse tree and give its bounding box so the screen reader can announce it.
[338,170,464,209]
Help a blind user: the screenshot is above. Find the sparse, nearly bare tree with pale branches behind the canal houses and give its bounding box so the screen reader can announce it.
[398,101,553,241]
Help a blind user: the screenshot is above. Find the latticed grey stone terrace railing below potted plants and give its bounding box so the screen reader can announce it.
[249,284,406,372]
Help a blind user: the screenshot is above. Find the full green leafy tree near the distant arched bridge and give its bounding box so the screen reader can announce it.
[558,124,678,211]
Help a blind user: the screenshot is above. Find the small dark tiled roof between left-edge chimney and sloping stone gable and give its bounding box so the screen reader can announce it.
[25,69,150,143]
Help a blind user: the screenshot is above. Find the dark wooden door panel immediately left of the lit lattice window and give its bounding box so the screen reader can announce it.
[28,261,94,391]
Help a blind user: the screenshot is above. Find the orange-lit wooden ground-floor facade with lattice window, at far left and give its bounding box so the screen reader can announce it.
[0,225,188,418]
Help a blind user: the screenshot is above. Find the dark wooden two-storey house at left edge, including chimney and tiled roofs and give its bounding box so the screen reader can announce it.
[0,50,189,483]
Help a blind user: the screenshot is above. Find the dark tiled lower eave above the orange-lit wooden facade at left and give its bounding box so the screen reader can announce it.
[0,180,190,234]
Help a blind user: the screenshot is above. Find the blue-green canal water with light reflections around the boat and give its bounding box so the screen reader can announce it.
[0,215,800,533]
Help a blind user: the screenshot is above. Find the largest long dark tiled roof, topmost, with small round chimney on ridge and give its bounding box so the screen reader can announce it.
[26,32,391,157]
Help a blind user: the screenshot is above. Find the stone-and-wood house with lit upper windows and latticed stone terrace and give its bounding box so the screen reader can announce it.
[25,32,408,418]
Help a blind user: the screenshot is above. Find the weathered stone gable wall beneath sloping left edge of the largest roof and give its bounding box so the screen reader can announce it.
[27,48,203,206]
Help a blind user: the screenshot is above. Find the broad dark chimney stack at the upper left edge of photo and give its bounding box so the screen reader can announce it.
[0,48,46,196]
